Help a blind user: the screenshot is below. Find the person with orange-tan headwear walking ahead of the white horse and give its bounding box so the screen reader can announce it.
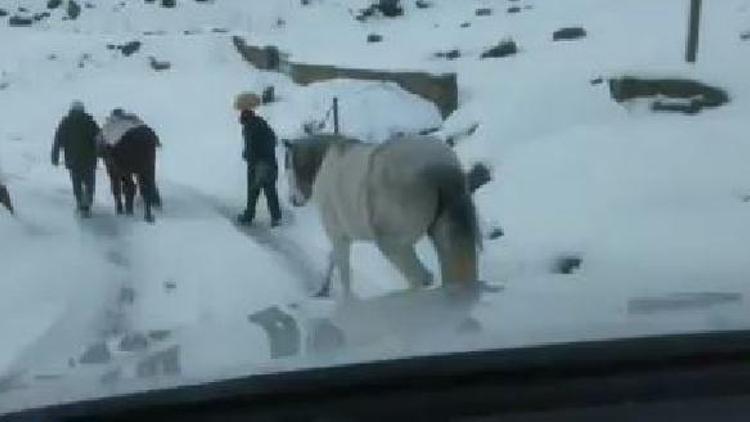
[234,92,281,227]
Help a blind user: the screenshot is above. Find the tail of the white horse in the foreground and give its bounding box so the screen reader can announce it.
[429,163,482,284]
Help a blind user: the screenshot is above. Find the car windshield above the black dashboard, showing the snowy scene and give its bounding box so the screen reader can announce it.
[0,0,750,415]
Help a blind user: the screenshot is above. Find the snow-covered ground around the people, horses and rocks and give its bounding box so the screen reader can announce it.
[0,0,750,413]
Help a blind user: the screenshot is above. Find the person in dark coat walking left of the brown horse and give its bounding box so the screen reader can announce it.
[52,101,99,217]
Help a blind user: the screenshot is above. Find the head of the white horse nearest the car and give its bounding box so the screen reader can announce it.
[284,136,340,207]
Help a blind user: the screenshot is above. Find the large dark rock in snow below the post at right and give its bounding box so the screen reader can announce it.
[609,76,730,114]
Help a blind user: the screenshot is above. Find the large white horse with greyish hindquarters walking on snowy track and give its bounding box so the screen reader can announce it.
[284,135,481,296]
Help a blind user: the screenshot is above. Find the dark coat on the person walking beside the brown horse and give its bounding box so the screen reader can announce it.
[52,111,99,170]
